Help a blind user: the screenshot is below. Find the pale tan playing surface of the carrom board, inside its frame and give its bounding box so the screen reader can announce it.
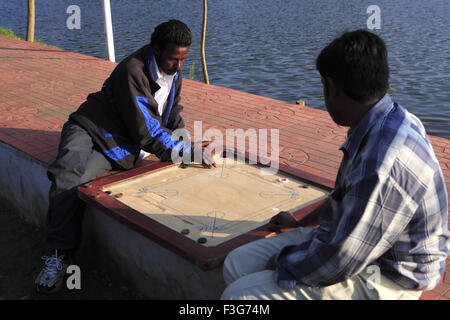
[102,157,327,247]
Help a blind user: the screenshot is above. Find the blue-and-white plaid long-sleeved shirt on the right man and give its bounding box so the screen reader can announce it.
[276,96,450,290]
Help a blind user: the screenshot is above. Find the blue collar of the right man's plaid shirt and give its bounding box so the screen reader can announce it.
[339,95,394,157]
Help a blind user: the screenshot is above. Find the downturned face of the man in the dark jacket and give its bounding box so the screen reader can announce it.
[154,43,189,75]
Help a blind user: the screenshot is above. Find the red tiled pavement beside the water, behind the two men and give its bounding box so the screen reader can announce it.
[0,36,450,300]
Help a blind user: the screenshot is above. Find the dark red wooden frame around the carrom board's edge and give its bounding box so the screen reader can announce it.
[78,152,334,270]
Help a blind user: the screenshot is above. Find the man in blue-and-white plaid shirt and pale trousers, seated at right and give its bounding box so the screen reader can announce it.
[222,30,450,299]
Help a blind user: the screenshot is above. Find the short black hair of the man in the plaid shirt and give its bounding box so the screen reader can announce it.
[316,29,389,102]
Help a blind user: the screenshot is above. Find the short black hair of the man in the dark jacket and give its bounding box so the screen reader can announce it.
[150,19,192,50]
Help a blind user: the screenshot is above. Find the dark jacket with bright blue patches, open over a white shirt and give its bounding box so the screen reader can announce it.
[69,45,190,169]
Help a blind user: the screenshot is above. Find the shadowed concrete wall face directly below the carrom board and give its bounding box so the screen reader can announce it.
[80,206,225,299]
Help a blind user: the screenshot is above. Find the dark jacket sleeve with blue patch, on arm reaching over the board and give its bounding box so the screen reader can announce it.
[113,66,191,161]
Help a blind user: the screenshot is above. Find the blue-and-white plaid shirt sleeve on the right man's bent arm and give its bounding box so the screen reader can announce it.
[276,173,418,287]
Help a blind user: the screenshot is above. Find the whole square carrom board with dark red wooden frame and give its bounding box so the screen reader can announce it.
[80,155,328,269]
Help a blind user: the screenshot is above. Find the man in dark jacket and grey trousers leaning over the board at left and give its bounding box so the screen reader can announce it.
[36,20,214,293]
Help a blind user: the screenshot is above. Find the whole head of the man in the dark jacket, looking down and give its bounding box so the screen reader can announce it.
[150,20,192,74]
